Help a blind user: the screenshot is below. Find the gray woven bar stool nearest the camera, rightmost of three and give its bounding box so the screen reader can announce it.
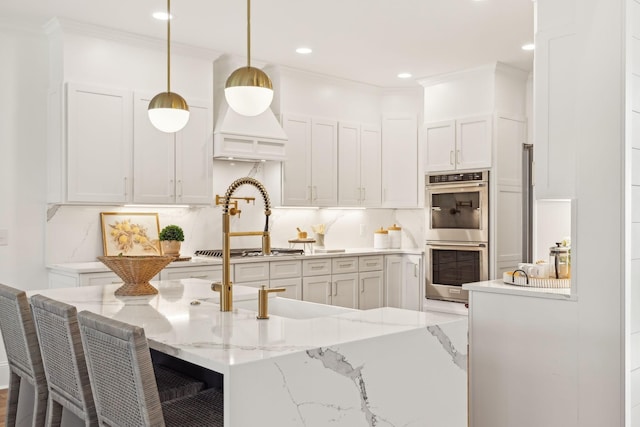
[78,311,223,427]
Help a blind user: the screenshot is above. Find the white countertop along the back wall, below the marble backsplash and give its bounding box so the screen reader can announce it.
[47,248,423,273]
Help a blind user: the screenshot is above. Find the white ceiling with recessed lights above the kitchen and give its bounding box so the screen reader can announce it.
[0,0,534,87]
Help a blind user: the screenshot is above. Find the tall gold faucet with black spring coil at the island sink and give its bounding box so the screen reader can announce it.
[211,177,271,311]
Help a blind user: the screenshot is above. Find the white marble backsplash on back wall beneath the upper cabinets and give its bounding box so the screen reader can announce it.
[46,205,424,264]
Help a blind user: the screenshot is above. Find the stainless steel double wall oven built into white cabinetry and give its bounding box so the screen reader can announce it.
[425,171,489,303]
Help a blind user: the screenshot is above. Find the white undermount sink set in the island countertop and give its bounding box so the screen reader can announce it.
[233,297,357,319]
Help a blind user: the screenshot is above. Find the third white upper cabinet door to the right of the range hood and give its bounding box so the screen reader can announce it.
[338,123,362,206]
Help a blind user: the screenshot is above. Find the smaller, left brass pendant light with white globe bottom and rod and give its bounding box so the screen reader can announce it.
[147,0,189,133]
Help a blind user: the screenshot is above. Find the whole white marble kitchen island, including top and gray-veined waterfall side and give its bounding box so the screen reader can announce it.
[31,279,467,427]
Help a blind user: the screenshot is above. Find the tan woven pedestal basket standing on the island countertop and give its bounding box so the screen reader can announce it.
[98,256,174,296]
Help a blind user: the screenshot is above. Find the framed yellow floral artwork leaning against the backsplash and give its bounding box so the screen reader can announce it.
[100,212,162,256]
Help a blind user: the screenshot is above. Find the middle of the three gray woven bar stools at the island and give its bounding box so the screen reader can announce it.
[31,295,204,427]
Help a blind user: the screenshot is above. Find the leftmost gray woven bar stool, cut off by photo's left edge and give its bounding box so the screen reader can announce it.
[0,284,48,427]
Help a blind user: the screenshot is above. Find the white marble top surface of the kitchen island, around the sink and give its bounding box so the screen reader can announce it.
[30,279,463,374]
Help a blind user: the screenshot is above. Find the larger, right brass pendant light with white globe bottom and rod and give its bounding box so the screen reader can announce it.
[224,0,273,116]
